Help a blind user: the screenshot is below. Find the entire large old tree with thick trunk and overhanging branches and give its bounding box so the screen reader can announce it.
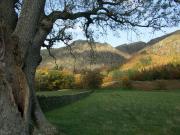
[0,0,180,135]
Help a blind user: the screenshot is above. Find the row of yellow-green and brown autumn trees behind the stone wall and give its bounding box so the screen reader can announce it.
[35,69,103,91]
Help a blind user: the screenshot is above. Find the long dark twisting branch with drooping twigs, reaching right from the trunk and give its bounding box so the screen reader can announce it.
[38,0,180,69]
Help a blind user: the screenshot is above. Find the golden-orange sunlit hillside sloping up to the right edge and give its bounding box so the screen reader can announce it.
[120,31,180,70]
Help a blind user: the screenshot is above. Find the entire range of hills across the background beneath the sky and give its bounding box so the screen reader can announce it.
[40,30,180,70]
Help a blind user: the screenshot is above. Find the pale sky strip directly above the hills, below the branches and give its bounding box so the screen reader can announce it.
[55,26,180,48]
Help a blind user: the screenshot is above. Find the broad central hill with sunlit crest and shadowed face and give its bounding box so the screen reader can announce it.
[40,40,130,70]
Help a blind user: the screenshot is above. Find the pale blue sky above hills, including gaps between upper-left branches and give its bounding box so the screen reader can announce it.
[45,0,180,47]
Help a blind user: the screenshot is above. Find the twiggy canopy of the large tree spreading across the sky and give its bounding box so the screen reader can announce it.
[13,0,180,47]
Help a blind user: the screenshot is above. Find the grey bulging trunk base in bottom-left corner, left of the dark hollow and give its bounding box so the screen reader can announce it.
[0,72,27,135]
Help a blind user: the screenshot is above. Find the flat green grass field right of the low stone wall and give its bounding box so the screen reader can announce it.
[45,90,180,135]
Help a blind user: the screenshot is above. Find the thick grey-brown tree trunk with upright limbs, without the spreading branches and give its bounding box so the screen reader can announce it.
[0,0,57,135]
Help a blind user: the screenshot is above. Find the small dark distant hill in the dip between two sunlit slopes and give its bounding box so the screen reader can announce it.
[116,41,148,54]
